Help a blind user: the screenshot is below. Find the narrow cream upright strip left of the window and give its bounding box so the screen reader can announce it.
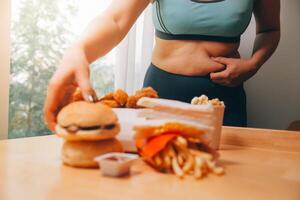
[0,0,10,139]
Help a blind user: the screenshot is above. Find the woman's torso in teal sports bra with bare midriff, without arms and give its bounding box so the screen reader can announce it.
[152,0,253,76]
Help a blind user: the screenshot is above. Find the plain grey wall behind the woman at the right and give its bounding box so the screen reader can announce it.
[240,0,300,129]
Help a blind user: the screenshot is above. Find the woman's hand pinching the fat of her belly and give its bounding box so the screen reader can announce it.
[210,57,257,87]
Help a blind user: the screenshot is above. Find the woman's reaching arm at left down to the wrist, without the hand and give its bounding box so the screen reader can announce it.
[75,0,150,63]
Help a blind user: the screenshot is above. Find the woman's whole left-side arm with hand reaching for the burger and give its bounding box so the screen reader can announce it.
[44,0,150,131]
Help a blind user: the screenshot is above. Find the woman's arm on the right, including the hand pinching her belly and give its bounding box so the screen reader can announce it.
[211,0,280,86]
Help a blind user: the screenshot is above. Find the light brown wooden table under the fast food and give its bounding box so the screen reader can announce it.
[0,127,300,200]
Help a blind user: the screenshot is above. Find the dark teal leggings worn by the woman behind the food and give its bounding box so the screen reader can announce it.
[144,64,247,127]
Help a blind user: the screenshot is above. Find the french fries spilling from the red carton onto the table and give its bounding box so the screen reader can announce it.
[152,136,224,179]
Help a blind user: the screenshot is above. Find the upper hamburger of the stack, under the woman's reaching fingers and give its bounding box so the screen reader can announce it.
[55,101,120,141]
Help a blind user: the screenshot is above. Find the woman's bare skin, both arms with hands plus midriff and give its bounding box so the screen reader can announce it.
[44,0,280,131]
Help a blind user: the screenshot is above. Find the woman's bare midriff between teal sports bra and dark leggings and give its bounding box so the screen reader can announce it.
[152,38,239,76]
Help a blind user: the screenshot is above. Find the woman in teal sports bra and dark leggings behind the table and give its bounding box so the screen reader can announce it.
[44,0,280,130]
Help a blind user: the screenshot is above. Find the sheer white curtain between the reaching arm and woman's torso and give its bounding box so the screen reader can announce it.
[115,5,154,94]
